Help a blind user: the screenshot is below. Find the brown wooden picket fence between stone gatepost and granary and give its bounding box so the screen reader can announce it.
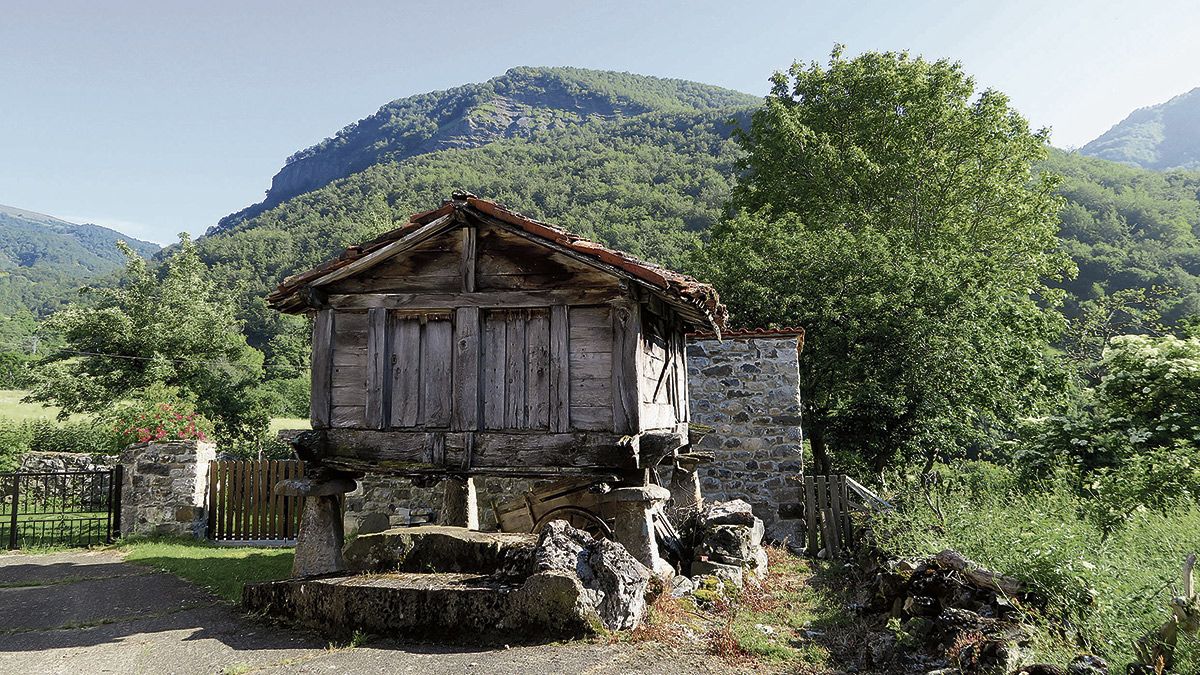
[208,460,304,542]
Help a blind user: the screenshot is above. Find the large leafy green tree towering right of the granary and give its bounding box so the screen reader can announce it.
[697,48,1069,471]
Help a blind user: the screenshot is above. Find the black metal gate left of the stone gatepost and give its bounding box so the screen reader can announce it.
[0,465,122,549]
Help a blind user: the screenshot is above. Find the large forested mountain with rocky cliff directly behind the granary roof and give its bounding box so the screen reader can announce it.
[197,68,760,347]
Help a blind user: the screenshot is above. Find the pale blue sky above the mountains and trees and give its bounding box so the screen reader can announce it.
[0,0,1200,243]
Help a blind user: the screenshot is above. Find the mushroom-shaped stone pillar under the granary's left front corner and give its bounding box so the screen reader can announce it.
[275,476,358,577]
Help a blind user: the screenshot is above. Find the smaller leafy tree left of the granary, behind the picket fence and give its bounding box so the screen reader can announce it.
[28,234,270,438]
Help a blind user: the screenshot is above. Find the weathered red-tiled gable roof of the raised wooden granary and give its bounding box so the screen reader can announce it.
[268,192,727,331]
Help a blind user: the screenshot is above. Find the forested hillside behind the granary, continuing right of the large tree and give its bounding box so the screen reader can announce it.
[198,68,1200,357]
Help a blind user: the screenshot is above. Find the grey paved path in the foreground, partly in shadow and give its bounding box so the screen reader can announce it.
[0,552,731,675]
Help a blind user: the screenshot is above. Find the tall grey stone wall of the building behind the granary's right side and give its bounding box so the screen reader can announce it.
[688,330,804,533]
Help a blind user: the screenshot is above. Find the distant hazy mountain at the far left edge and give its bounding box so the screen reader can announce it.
[0,205,160,315]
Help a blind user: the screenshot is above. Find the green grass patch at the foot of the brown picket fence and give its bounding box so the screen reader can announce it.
[118,539,292,603]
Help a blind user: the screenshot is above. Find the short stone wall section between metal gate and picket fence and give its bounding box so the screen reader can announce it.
[121,441,216,537]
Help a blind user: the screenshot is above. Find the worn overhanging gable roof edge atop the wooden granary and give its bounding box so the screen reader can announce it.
[268,193,727,335]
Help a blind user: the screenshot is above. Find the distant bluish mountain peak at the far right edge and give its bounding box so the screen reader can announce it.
[1079,88,1200,171]
